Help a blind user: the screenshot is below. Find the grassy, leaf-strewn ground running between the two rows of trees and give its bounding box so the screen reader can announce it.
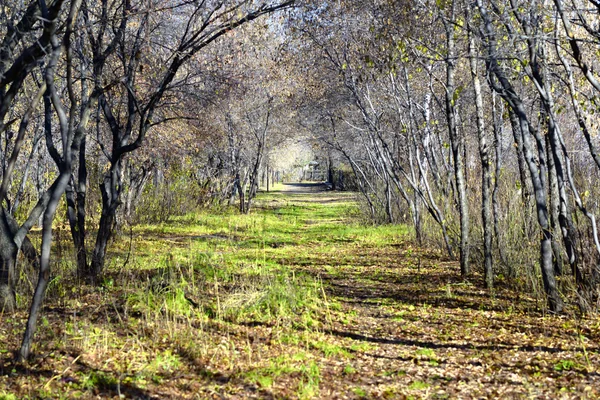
[0,185,600,399]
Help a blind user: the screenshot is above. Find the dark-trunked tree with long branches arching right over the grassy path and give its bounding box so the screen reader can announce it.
[72,1,293,280]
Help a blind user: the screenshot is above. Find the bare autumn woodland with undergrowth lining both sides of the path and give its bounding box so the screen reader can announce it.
[0,0,600,396]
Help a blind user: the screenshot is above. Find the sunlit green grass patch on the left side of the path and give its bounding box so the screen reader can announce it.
[0,186,360,398]
